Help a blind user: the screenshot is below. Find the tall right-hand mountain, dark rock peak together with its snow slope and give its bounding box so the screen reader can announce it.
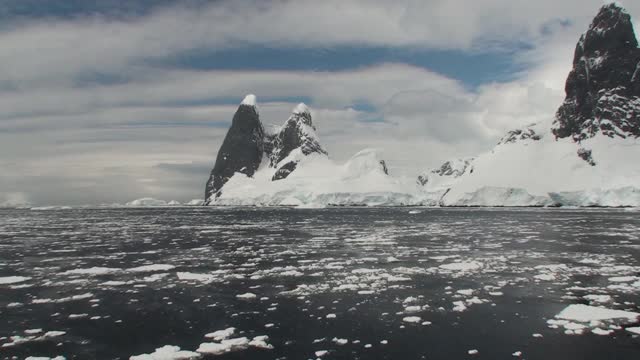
[422,4,640,206]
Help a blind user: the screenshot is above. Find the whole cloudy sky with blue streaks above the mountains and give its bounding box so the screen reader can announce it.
[0,0,640,205]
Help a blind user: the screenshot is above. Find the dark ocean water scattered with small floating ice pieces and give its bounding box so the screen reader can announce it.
[0,208,640,359]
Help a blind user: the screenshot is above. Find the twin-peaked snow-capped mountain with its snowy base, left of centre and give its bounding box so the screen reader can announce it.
[205,95,418,206]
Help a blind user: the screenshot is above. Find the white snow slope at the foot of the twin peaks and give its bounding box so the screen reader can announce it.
[213,149,422,207]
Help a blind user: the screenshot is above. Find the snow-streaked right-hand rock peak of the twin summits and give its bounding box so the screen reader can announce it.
[268,104,327,180]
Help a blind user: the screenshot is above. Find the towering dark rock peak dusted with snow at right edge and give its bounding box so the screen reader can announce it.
[552,4,640,142]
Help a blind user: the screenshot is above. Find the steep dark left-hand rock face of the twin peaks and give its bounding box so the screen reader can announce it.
[205,104,264,204]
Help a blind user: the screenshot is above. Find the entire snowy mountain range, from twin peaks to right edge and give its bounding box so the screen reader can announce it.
[205,4,640,206]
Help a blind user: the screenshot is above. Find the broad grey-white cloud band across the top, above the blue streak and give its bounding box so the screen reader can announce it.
[0,0,640,88]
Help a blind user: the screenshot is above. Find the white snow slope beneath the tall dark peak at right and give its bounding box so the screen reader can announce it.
[425,124,640,206]
